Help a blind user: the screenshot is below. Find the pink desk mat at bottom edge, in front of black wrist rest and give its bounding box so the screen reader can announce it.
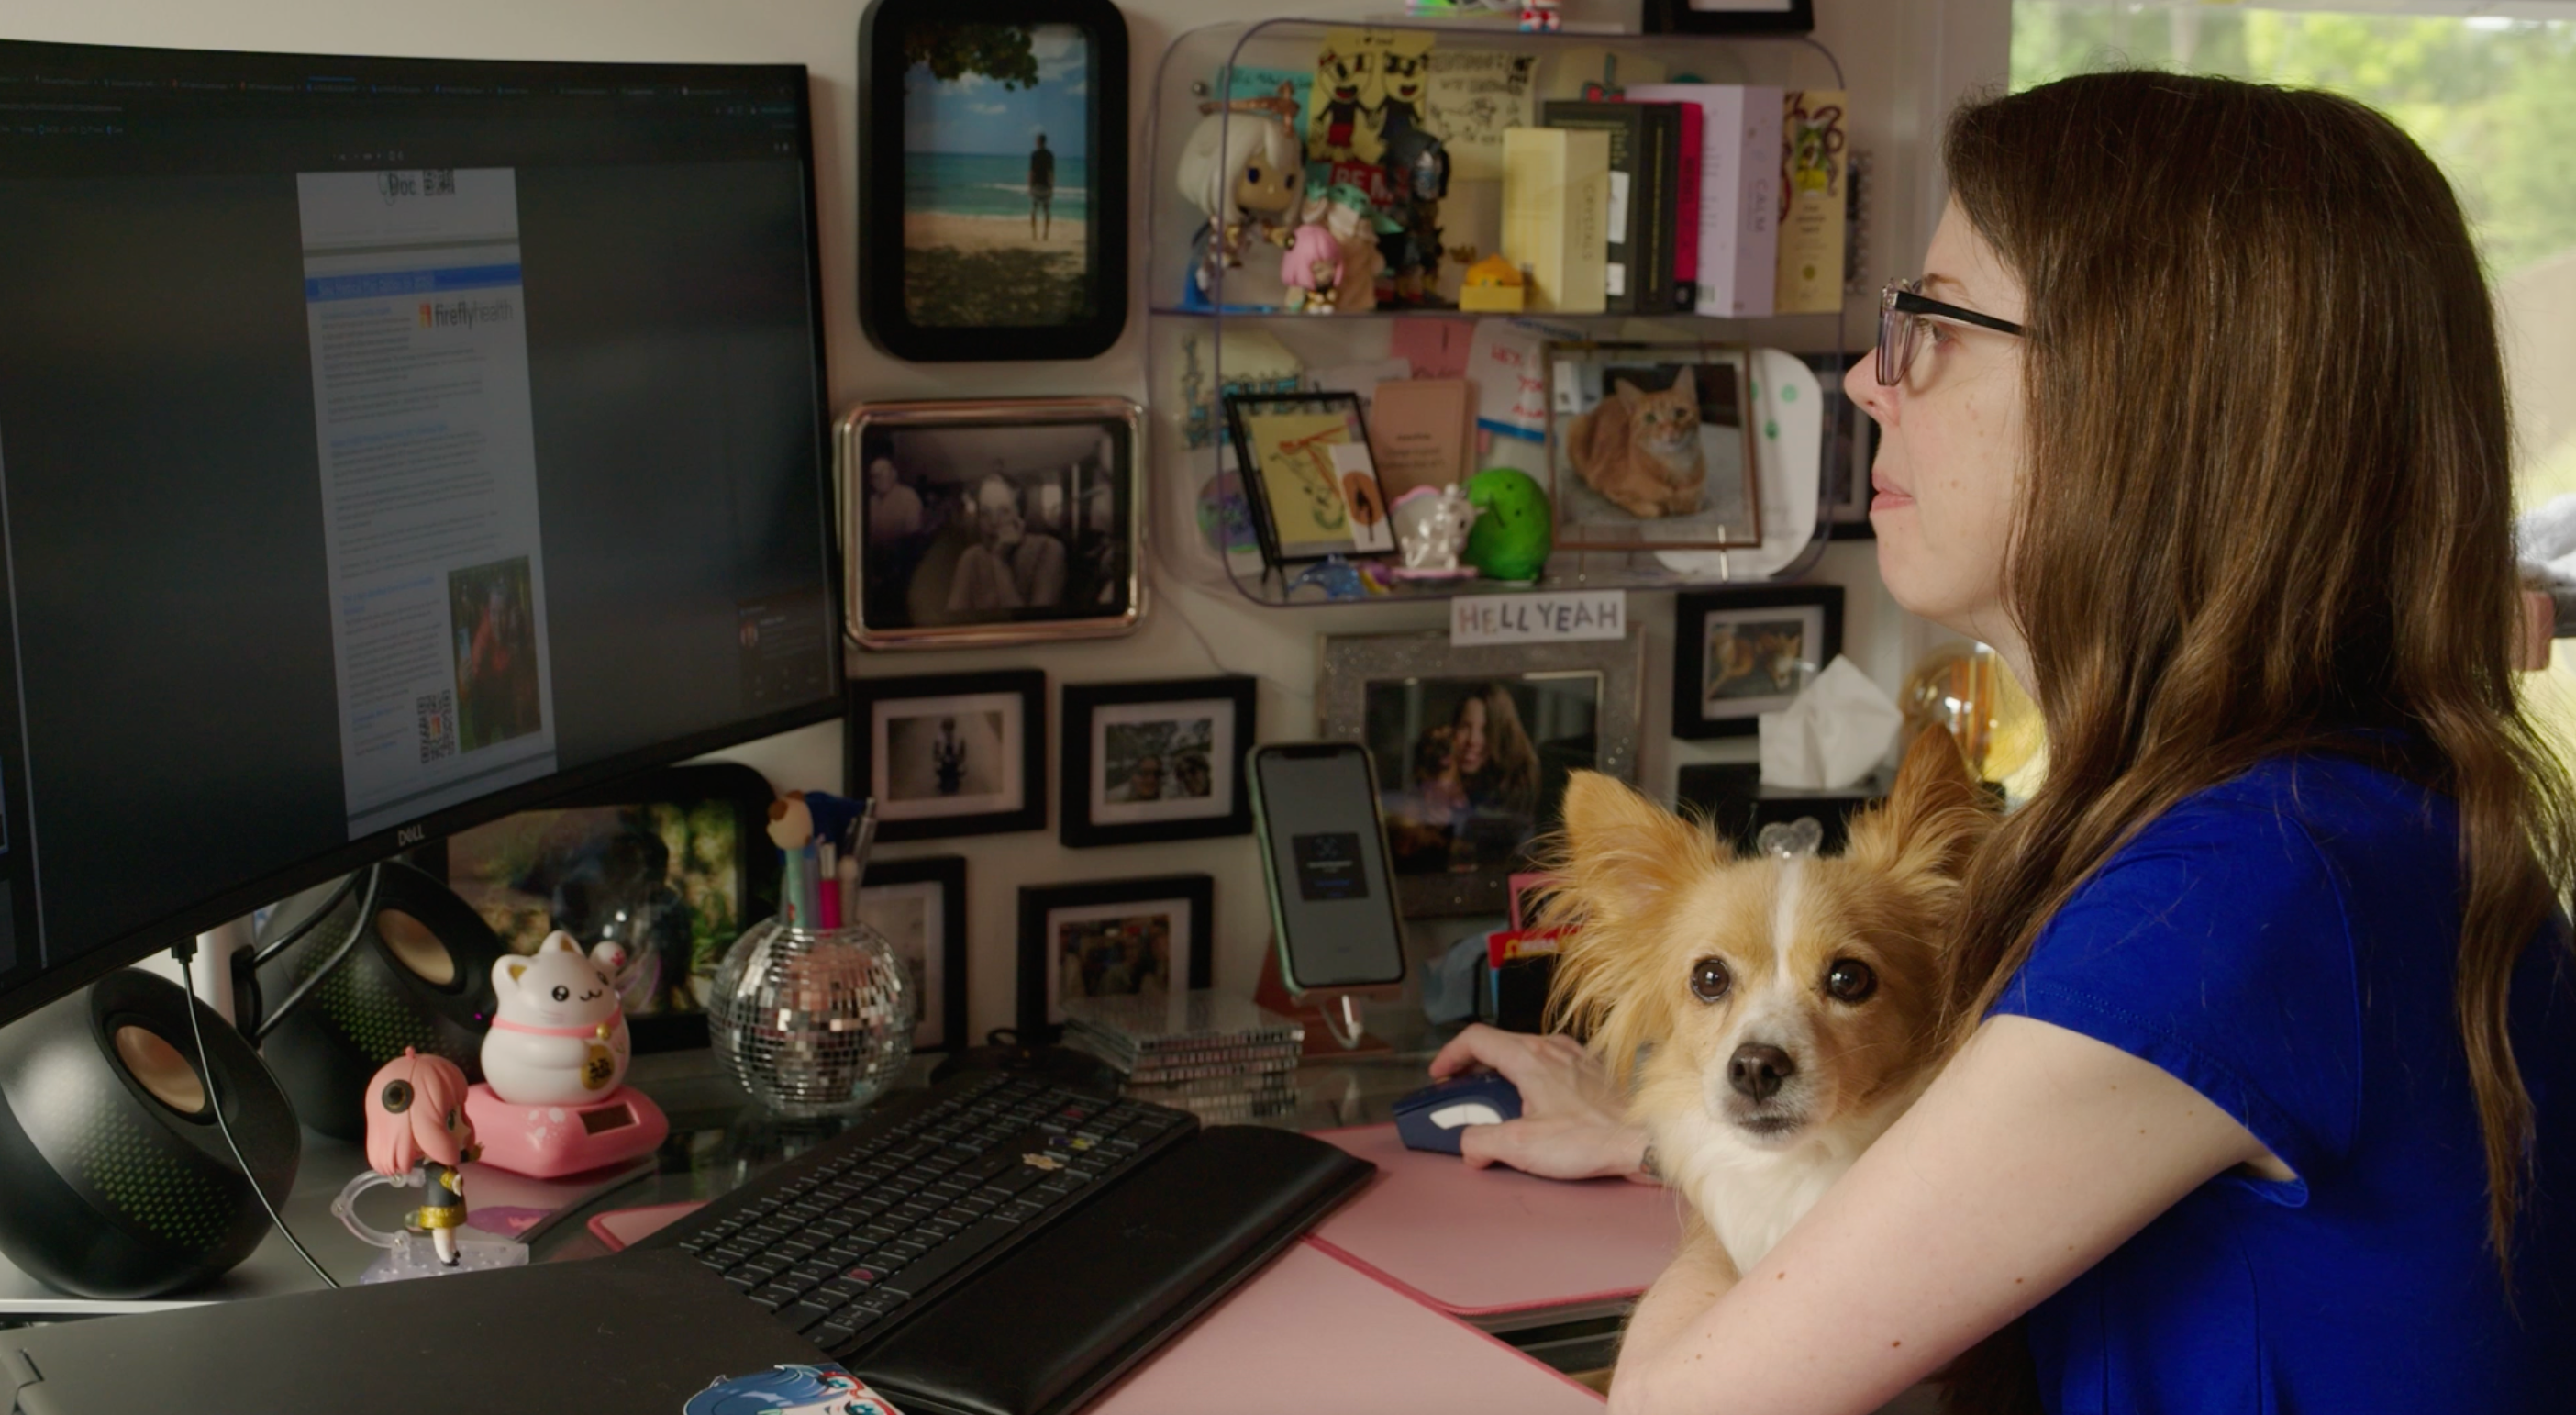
[1084,1242,1603,1415]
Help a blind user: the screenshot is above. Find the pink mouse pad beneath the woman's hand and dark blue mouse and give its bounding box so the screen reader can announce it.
[1308,1124,1682,1317]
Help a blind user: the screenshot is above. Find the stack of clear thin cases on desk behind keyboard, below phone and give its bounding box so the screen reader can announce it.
[1064,990,1306,1124]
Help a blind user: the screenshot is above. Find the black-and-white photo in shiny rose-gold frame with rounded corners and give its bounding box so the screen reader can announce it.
[835,397,1144,650]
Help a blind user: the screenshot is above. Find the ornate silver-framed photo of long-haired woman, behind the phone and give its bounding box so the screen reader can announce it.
[1316,634,1638,918]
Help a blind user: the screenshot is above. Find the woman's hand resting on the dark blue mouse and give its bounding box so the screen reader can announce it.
[1432,1023,1649,1180]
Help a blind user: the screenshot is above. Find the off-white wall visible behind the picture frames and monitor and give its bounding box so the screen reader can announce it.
[19,0,2009,1033]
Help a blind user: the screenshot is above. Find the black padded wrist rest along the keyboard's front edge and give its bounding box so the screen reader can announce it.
[850,1126,1375,1415]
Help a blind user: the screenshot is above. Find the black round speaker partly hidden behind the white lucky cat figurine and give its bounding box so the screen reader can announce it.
[252,861,507,1144]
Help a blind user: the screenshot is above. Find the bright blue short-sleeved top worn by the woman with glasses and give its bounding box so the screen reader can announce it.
[1993,755,2576,1415]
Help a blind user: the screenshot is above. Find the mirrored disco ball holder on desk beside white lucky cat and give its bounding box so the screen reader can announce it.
[705,918,917,1116]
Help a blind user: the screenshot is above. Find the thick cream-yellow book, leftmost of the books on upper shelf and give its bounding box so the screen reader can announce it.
[1502,128,1610,315]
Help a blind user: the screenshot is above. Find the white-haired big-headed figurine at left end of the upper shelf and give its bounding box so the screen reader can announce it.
[1174,98,1306,309]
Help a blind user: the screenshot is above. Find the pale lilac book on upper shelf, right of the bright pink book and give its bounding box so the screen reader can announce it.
[1628,83,1785,319]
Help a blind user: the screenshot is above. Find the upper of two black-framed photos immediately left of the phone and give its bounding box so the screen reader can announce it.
[1056,678,1257,848]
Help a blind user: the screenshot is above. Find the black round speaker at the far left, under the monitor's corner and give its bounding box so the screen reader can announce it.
[0,969,302,1299]
